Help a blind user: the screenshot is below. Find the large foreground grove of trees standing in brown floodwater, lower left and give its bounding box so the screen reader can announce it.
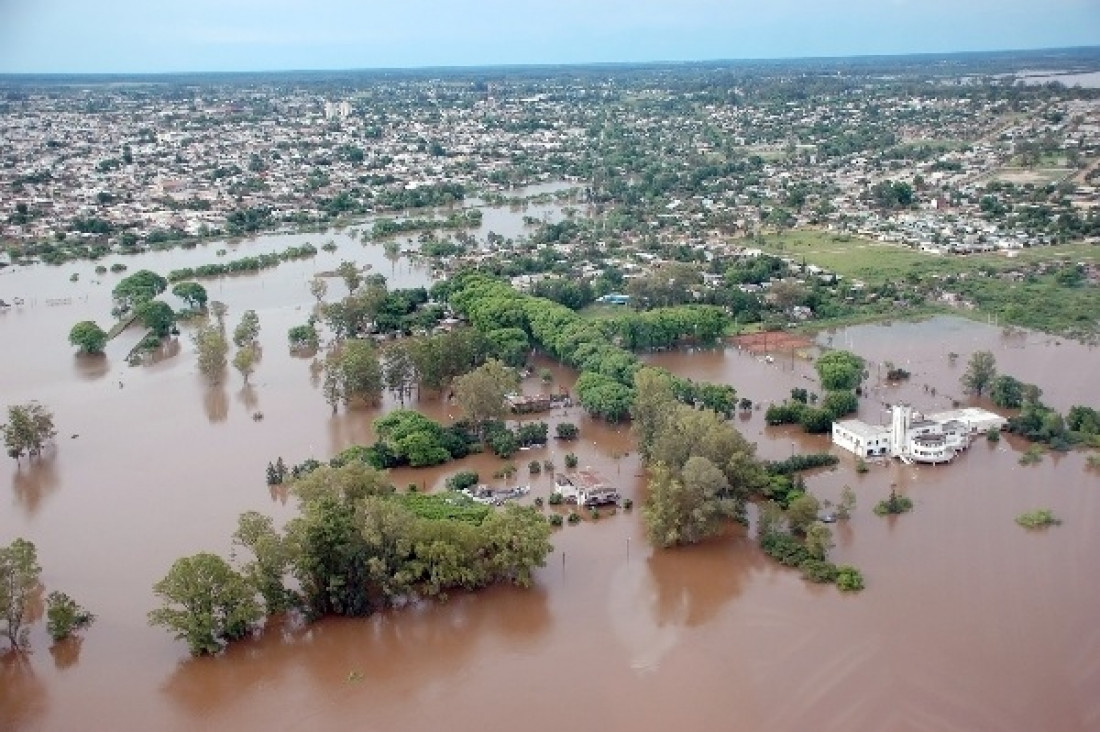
[150,460,552,655]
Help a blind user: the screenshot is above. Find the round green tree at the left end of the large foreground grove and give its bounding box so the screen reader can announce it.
[149,553,264,656]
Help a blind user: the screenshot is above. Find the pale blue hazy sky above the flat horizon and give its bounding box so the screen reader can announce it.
[0,0,1100,73]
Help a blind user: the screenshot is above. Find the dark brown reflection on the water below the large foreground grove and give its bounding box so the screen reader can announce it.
[162,587,550,723]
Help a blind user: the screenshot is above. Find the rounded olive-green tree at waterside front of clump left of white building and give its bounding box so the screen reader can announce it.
[642,457,733,547]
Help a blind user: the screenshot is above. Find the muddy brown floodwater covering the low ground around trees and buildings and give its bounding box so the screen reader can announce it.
[0,226,1100,732]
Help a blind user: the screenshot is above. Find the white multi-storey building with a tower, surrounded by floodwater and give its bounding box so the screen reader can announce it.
[833,404,1008,465]
